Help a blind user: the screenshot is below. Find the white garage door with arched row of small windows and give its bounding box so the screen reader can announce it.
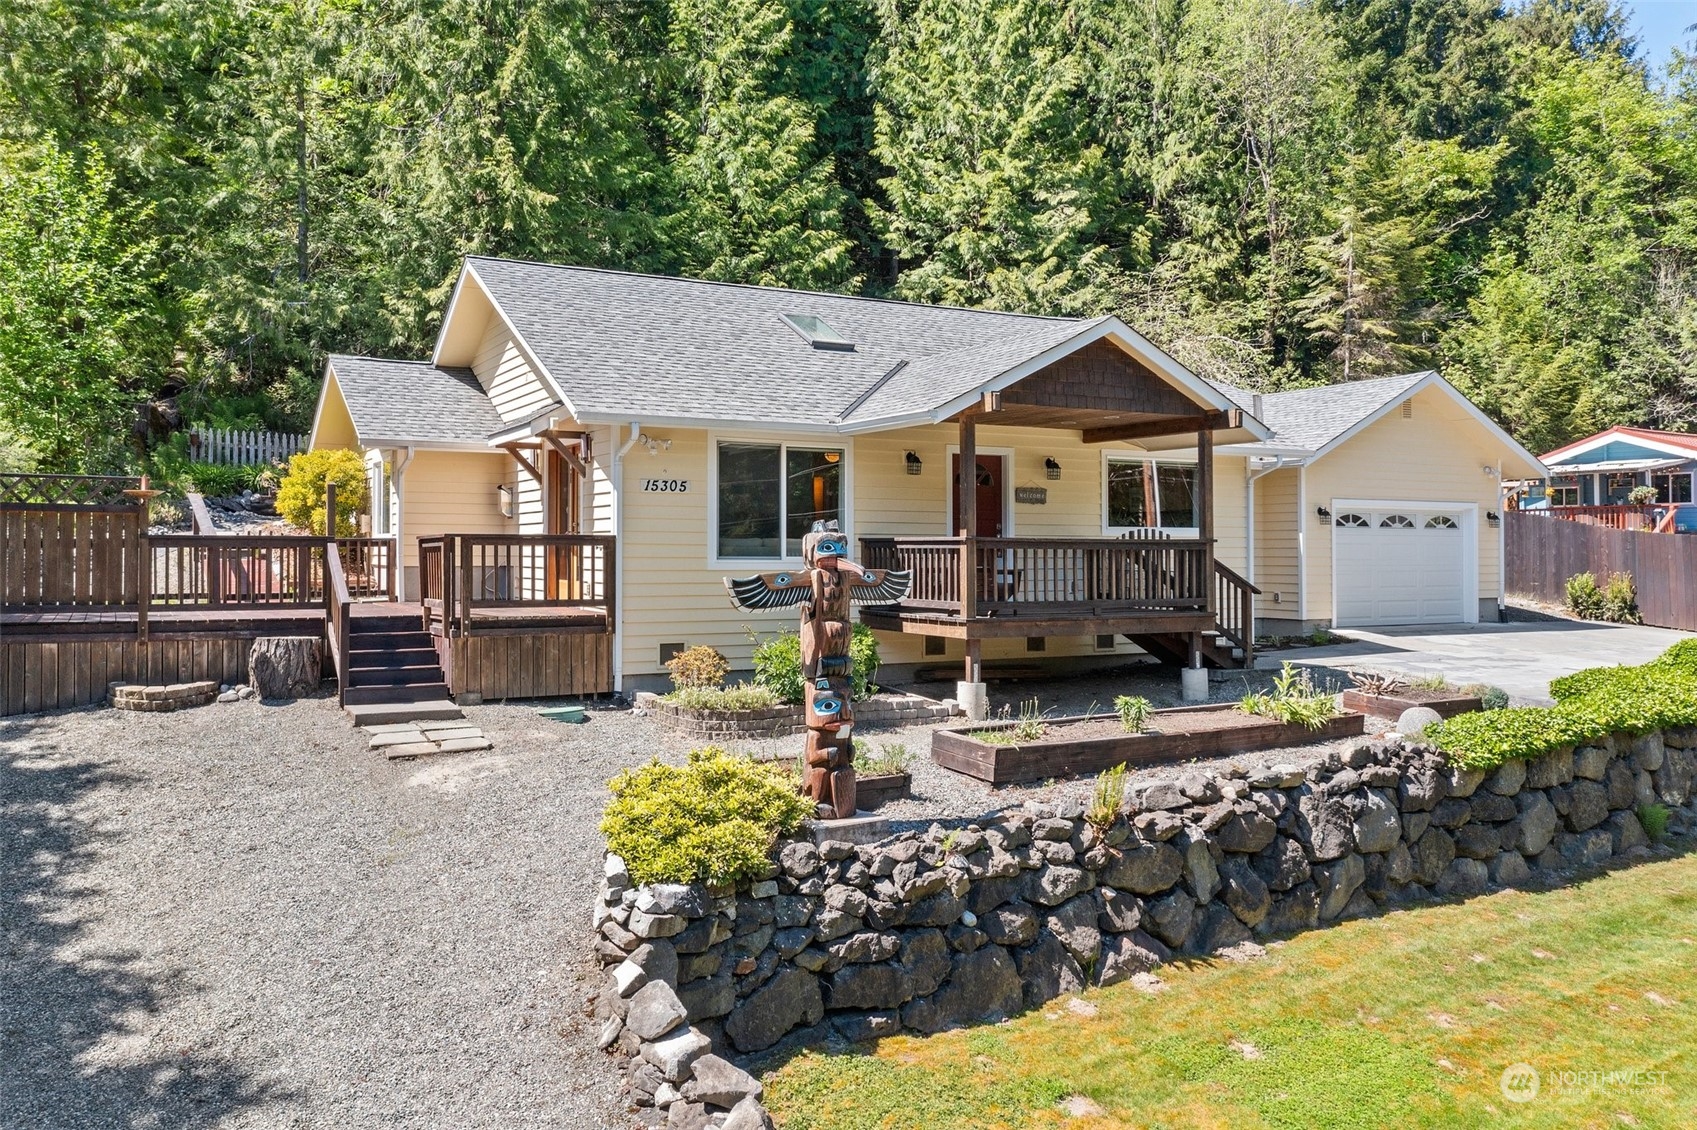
[1332,506,1478,628]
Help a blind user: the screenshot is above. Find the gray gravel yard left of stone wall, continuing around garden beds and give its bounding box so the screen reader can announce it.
[0,654,1364,1130]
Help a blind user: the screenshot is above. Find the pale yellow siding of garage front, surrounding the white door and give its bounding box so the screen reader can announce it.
[1308,389,1504,619]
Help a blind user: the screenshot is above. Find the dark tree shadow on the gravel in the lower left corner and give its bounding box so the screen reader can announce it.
[0,719,287,1130]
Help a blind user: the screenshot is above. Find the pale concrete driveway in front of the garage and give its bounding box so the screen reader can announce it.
[1256,619,1692,702]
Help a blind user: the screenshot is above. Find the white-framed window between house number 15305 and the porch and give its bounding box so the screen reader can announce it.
[714,441,843,558]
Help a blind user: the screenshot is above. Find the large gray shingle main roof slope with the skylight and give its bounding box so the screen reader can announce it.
[467,258,1091,426]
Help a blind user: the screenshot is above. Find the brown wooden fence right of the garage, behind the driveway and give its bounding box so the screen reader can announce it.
[1504,511,1697,631]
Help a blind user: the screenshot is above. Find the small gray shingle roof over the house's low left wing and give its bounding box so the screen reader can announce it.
[329,355,502,446]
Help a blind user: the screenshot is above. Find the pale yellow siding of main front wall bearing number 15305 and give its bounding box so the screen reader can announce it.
[617,424,1244,677]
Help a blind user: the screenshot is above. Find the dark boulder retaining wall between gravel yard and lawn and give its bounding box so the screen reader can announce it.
[594,730,1697,1127]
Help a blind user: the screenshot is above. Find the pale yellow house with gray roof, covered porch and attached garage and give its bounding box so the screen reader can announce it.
[311,258,1543,689]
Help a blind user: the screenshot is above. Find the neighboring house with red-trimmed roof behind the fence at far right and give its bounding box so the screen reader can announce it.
[1522,428,1697,531]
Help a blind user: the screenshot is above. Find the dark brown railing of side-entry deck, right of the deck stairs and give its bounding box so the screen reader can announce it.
[419,534,616,635]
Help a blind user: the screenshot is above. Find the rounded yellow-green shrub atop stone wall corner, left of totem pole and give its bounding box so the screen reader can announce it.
[601,748,813,884]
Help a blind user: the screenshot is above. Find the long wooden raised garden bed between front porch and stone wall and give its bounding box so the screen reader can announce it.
[932,704,1366,784]
